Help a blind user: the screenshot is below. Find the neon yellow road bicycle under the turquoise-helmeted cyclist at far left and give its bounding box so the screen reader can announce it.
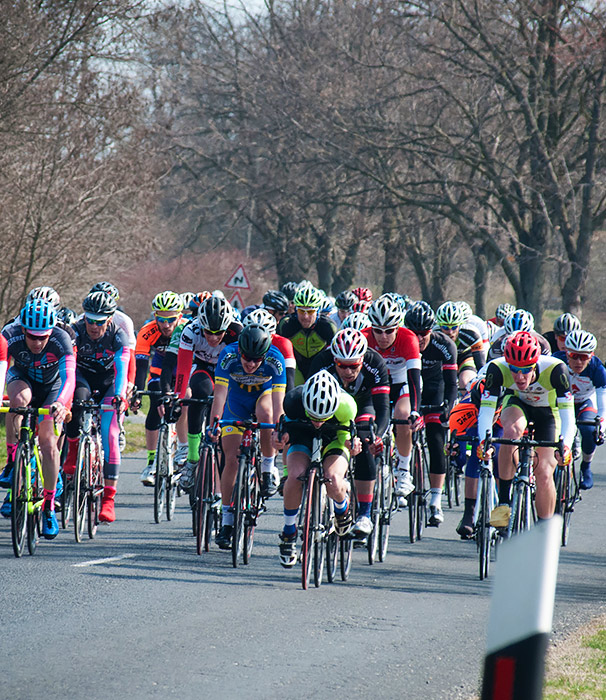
[0,406,58,557]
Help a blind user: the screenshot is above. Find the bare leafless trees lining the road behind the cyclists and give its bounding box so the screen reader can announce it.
[0,0,606,341]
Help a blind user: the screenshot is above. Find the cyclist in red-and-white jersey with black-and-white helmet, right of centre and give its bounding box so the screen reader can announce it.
[362,294,422,505]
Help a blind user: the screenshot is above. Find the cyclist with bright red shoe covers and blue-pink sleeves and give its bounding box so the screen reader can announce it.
[63,292,130,523]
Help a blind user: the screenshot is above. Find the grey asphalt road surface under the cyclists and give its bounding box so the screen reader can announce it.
[0,448,606,700]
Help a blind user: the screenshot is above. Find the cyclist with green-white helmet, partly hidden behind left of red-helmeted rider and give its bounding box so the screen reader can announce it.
[436,301,486,392]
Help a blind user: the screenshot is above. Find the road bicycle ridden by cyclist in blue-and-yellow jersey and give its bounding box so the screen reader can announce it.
[219,417,276,567]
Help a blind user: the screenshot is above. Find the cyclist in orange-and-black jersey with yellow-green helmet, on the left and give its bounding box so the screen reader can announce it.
[132,291,187,486]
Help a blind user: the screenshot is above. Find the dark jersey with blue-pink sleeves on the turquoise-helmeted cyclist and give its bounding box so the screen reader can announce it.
[3,324,76,406]
